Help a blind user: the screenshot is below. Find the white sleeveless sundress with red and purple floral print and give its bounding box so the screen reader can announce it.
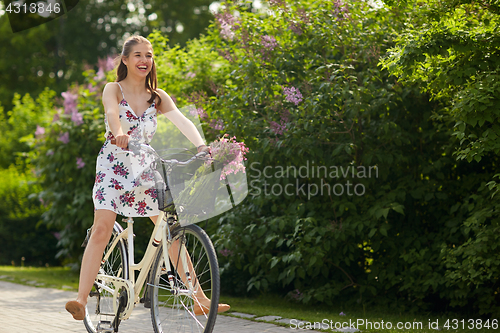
[92,83,159,217]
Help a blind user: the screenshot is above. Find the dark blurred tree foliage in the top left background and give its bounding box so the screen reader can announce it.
[0,0,212,110]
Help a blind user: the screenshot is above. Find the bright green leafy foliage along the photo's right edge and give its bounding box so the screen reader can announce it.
[382,0,500,314]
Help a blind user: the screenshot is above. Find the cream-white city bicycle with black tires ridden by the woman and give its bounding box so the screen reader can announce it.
[84,143,220,333]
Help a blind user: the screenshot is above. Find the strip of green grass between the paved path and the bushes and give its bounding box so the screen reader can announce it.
[0,266,500,333]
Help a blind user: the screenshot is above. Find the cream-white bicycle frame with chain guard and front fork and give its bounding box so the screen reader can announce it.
[95,211,196,320]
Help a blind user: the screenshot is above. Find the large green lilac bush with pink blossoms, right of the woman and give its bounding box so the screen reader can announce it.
[149,1,498,313]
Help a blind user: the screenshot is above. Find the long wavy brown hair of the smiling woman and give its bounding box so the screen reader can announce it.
[116,35,161,106]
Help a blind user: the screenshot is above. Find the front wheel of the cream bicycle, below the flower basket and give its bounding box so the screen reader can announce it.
[149,224,220,333]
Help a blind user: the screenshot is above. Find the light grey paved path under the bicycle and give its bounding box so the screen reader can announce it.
[0,281,296,333]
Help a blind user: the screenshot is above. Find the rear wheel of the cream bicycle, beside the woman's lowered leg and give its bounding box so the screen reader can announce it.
[83,222,129,333]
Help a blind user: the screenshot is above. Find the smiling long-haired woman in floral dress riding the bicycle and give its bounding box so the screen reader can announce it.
[66,36,229,320]
